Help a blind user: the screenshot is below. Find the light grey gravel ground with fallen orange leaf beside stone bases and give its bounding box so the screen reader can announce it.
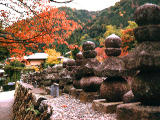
[50,94,116,120]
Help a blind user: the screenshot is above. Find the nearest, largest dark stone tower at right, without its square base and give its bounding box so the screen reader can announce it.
[126,4,160,105]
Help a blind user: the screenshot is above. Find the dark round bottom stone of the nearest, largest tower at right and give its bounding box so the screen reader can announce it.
[131,71,160,106]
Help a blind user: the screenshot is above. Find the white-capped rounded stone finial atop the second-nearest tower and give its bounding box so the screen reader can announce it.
[105,34,122,56]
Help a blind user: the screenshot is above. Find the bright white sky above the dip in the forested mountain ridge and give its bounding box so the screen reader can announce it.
[52,0,120,11]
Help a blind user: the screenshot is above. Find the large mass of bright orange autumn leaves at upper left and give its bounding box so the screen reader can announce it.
[2,8,81,57]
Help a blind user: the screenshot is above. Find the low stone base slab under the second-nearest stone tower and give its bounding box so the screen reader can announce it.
[92,99,123,113]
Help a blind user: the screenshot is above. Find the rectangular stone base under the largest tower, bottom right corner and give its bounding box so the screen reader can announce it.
[116,102,160,120]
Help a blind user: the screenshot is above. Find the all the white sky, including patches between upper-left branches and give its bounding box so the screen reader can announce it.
[0,0,120,24]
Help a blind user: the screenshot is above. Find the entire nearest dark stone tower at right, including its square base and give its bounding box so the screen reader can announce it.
[117,3,160,120]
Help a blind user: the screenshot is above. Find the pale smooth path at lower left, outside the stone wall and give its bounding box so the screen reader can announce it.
[0,90,15,120]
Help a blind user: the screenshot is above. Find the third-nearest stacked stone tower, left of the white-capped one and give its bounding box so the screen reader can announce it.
[73,41,103,92]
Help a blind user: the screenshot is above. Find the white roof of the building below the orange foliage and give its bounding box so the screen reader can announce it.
[24,53,48,60]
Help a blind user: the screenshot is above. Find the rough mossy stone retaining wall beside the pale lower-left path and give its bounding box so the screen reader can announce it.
[13,82,52,120]
